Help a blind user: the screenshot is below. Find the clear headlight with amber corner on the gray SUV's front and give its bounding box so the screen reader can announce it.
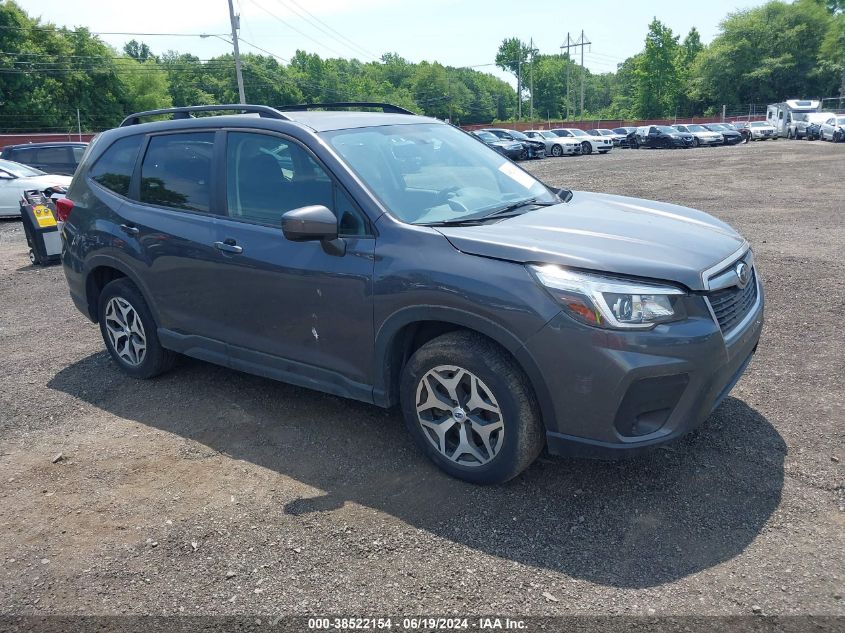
[528,265,686,330]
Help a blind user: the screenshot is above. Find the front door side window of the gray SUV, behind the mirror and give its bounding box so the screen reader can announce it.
[226,132,338,226]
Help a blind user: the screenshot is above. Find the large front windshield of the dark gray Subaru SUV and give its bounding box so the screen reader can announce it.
[323,123,560,224]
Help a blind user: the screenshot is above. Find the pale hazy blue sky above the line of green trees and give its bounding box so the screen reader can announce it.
[21,0,763,84]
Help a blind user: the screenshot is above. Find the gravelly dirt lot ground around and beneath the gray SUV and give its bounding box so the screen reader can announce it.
[0,140,845,616]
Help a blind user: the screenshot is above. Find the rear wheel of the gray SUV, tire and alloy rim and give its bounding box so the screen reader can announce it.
[97,277,176,378]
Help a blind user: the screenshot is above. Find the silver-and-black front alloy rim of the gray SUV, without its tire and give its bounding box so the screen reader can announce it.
[416,365,505,467]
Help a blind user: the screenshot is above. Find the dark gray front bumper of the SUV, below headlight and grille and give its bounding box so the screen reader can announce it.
[524,286,764,458]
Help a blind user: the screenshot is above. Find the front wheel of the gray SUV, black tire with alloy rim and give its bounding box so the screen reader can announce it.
[399,331,545,484]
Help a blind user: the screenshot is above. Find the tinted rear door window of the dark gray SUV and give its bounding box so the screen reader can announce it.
[141,132,214,213]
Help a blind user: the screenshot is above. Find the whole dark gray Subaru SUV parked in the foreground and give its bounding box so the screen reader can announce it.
[58,104,763,483]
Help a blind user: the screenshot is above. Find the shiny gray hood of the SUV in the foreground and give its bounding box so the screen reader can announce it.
[437,191,745,290]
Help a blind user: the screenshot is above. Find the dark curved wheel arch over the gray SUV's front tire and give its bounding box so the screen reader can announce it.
[373,306,554,434]
